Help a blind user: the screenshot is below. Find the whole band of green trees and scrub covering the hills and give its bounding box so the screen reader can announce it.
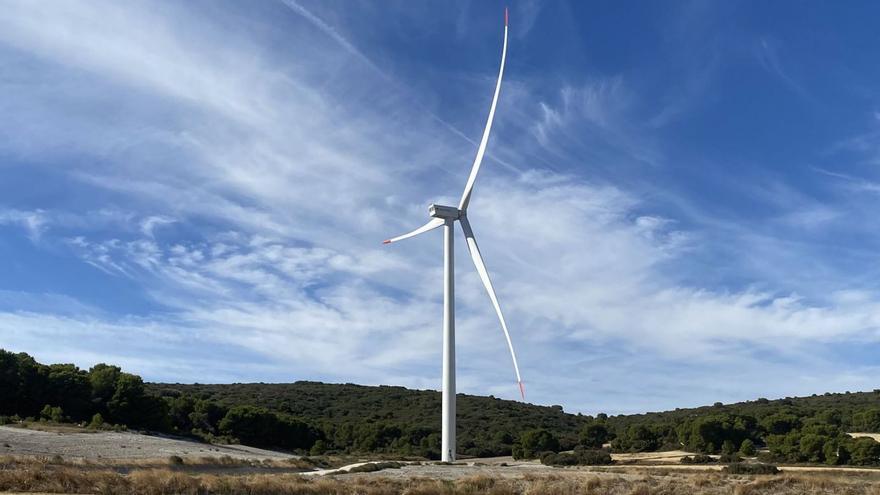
[0,350,880,465]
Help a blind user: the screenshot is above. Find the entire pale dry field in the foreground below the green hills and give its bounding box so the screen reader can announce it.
[0,427,880,495]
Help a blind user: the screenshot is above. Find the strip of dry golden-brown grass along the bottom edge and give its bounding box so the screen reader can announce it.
[0,459,880,495]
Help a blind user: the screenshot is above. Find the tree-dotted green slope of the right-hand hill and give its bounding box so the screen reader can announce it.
[597,390,880,465]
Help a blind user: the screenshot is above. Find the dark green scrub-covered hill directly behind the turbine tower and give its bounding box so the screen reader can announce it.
[147,381,584,455]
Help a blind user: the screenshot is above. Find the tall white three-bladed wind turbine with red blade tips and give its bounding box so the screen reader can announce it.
[384,8,525,462]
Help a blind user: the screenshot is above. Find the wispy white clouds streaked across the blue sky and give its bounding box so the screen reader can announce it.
[0,2,880,409]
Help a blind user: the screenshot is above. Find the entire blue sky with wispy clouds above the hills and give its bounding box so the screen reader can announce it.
[0,0,880,413]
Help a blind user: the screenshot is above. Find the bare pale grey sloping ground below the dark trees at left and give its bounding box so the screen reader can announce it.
[0,426,295,460]
